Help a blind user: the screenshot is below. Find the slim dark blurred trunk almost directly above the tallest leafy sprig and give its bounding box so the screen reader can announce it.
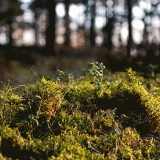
[90,0,96,47]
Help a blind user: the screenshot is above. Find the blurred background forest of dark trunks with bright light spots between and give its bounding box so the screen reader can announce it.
[0,0,160,82]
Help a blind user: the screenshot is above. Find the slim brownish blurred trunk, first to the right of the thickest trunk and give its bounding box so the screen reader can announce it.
[64,0,70,46]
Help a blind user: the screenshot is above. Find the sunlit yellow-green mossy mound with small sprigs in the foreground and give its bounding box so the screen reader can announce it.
[0,62,160,160]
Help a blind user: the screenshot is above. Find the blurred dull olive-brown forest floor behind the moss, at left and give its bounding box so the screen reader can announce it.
[0,55,94,86]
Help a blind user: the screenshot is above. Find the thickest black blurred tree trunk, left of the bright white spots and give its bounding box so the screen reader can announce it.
[45,0,56,54]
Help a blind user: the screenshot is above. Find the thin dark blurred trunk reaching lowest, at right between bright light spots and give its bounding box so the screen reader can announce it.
[126,0,132,57]
